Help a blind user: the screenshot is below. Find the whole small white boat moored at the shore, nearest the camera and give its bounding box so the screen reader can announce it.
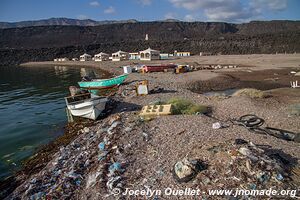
[65,93,108,120]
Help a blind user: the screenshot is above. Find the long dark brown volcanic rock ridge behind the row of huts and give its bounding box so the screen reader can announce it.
[0,21,300,65]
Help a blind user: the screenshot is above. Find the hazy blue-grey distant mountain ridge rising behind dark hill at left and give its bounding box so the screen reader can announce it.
[0,18,137,29]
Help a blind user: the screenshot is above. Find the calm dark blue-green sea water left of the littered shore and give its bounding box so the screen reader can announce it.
[0,66,108,179]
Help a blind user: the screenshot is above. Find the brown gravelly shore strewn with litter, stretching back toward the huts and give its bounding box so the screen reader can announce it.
[2,55,300,199]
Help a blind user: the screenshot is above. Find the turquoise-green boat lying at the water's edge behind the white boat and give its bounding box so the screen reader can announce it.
[78,74,128,94]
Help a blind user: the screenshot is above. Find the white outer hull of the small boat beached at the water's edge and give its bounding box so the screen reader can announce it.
[66,95,108,120]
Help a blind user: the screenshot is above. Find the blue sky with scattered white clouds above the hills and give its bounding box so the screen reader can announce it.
[0,0,300,23]
